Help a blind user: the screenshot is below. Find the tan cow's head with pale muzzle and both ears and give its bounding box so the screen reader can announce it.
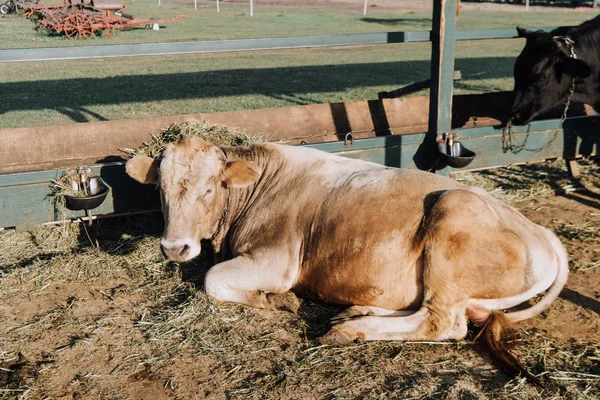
[126,137,262,262]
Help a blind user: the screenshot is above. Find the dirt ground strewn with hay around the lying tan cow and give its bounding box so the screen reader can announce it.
[0,161,600,399]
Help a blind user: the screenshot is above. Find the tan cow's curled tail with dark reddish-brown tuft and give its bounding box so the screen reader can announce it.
[467,235,569,386]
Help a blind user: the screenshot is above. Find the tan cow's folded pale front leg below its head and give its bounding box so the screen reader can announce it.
[204,253,299,312]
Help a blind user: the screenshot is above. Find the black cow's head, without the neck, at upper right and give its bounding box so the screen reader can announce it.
[510,27,591,125]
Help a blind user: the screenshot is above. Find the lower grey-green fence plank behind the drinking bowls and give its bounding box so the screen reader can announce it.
[0,116,600,229]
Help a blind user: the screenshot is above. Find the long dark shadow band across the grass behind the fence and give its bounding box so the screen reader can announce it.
[0,57,514,122]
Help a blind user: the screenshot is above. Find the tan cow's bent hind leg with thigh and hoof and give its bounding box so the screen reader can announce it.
[324,190,527,343]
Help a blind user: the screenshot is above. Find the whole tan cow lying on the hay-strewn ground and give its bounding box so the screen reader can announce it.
[127,138,568,382]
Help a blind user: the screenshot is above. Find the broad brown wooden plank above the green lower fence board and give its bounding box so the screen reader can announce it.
[5,92,592,175]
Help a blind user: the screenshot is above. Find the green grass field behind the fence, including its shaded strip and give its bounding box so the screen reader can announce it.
[0,0,593,128]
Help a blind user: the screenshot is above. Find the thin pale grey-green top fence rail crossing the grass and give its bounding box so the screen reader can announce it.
[0,27,556,63]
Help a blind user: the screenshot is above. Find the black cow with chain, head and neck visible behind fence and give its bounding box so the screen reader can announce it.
[509,15,600,125]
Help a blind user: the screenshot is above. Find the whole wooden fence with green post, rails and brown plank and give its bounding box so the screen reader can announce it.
[0,0,600,229]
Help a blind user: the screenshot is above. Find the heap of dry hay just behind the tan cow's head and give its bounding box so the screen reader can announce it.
[133,121,262,158]
